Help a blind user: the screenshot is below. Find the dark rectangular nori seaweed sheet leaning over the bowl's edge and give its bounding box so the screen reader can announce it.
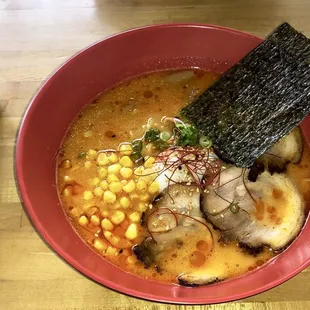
[181,23,310,167]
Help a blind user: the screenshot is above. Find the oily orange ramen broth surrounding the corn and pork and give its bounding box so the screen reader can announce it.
[57,71,310,283]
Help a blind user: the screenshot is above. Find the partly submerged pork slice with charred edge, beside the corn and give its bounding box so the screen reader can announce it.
[133,184,204,267]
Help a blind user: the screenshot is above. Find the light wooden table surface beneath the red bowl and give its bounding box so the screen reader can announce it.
[0,0,310,310]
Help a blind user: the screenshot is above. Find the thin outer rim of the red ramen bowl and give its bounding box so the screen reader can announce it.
[14,23,310,305]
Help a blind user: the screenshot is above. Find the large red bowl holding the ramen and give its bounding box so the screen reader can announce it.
[16,25,310,304]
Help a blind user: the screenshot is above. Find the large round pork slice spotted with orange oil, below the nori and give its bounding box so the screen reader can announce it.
[202,167,305,250]
